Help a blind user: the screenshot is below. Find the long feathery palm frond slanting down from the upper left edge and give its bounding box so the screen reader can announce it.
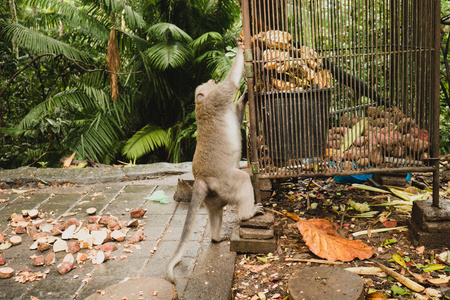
[0,23,90,61]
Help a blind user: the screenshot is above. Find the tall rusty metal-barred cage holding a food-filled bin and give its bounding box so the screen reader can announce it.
[241,0,440,206]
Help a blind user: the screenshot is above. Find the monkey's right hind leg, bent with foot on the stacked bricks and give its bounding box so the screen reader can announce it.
[233,169,264,220]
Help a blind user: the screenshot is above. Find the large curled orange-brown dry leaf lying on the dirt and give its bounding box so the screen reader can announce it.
[297,219,373,261]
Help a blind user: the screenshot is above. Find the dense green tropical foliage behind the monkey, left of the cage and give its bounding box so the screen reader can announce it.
[0,0,244,168]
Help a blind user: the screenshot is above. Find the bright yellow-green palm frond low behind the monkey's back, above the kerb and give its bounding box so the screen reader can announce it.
[122,124,169,159]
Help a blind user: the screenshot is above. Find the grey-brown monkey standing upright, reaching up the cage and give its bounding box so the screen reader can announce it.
[164,43,263,283]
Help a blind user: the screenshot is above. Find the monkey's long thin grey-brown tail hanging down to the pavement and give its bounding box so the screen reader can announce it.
[164,180,208,283]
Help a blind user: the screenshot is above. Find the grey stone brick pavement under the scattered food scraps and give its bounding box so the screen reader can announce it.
[0,163,236,300]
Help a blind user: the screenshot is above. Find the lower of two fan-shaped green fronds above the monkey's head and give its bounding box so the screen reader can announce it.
[145,42,192,70]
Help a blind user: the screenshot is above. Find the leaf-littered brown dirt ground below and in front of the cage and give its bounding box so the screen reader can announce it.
[233,173,450,300]
